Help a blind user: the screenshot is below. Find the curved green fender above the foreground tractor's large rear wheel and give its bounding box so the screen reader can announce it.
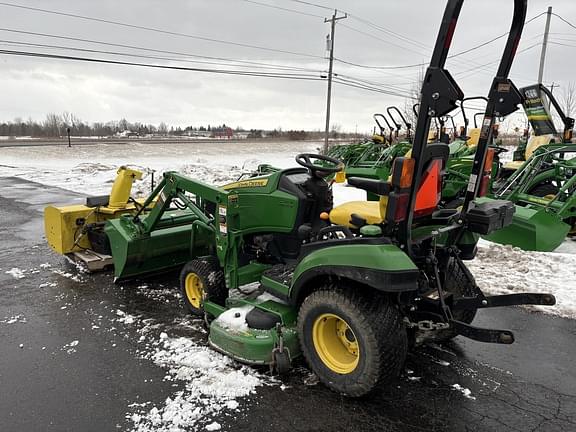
[289,244,419,301]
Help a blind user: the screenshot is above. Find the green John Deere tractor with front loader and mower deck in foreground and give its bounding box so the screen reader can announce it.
[46,0,555,397]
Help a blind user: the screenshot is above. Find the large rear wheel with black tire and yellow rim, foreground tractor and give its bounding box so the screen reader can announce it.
[298,289,408,397]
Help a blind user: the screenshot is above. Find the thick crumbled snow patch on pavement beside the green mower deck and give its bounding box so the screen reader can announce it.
[129,333,264,432]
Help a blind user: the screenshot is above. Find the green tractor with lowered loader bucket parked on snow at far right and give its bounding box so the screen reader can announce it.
[452,84,576,252]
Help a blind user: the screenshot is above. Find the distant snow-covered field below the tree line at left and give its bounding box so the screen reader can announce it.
[0,141,321,196]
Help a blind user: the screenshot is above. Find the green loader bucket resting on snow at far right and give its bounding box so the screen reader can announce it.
[483,206,570,252]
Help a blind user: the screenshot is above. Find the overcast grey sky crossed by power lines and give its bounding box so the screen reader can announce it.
[0,0,576,132]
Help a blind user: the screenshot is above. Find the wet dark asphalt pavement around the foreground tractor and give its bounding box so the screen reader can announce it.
[0,178,576,432]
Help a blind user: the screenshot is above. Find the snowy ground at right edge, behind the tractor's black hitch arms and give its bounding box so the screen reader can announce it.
[466,240,576,319]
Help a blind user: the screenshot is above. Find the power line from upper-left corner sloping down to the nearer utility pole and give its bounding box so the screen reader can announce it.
[0,2,323,59]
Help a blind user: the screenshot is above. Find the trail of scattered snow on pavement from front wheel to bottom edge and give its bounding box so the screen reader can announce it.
[114,308,275,432]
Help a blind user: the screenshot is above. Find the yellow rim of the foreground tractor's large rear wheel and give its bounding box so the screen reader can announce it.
[312,313,360,374]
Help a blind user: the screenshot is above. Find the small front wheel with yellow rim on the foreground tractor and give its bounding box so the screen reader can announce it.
[180,257,228,316]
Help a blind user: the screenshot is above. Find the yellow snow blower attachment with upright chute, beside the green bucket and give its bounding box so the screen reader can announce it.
[44,166,143,255]
